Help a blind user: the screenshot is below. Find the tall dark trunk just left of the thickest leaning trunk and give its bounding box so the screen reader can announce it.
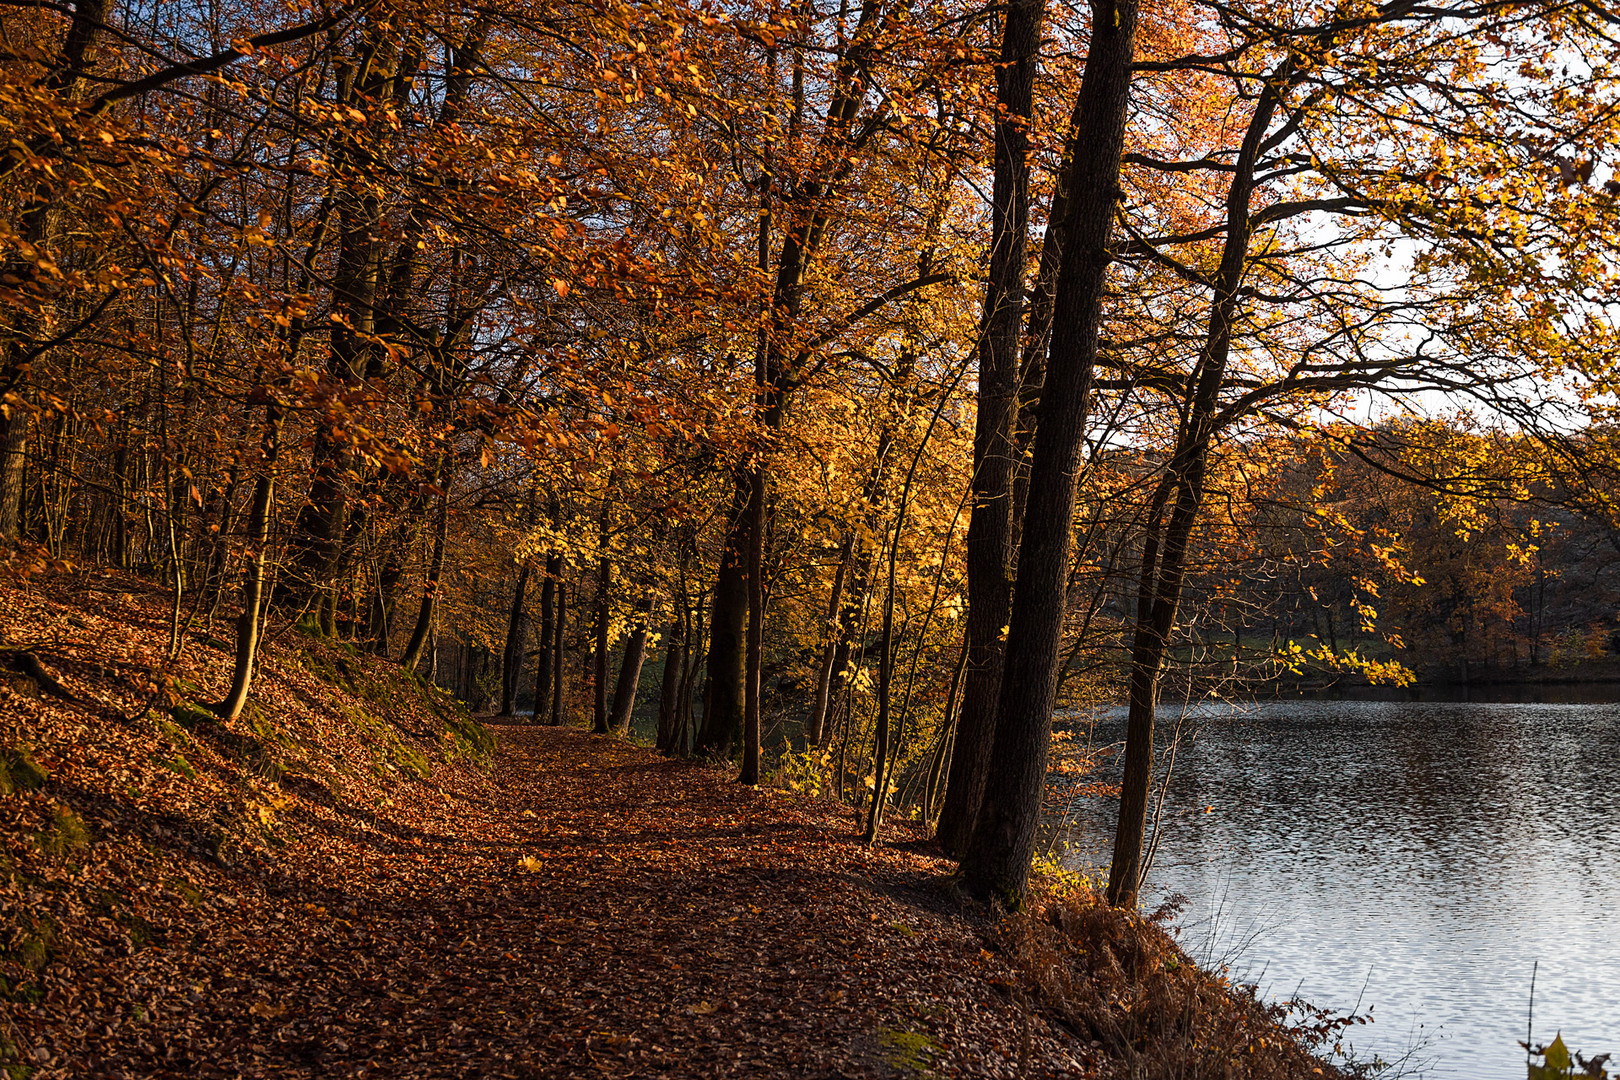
[938,0,1045,855]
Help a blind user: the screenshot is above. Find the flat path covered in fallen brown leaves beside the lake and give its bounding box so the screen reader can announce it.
[59,727,1082,1078]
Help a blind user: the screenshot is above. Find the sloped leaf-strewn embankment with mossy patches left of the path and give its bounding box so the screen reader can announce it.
[0,575,492,1077]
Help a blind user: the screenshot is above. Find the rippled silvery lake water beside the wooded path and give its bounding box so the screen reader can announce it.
[1068,701,1620,1080]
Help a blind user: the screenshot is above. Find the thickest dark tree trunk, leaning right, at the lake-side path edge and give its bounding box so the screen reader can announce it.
[956,0,1137,907]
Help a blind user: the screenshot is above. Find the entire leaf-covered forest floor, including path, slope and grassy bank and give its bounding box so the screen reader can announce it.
[0,575,1337,1080]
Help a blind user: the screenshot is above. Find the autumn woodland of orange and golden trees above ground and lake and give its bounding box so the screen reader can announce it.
[0,0,1620,899]
